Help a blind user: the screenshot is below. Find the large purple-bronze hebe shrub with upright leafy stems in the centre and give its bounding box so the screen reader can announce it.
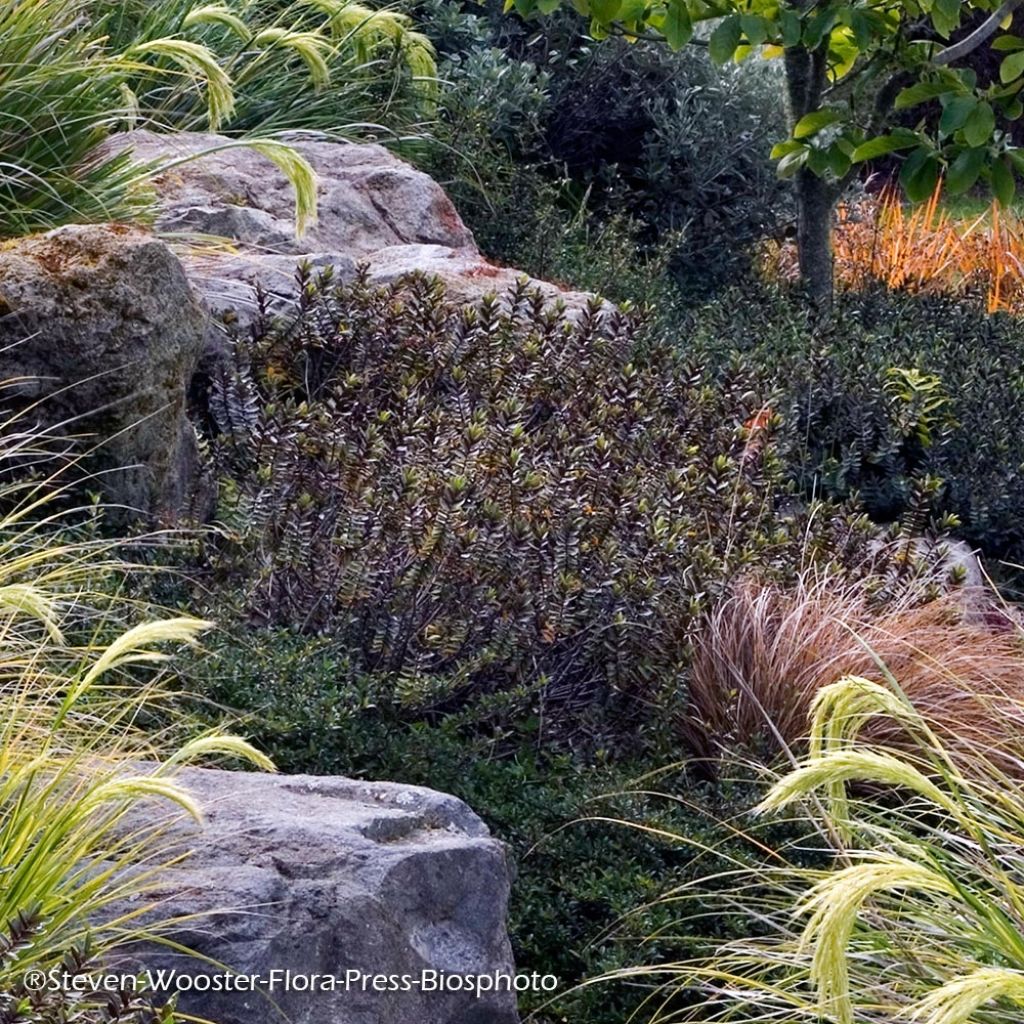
[205,269,863,731]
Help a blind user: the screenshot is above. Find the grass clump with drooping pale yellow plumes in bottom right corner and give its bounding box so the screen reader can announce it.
[610,672,1024,1024]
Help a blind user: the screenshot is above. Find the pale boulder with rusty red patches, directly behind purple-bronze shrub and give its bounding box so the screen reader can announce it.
[106,125,590,329]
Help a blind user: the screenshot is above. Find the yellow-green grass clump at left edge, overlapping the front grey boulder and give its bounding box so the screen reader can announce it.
[0,420,269,1024]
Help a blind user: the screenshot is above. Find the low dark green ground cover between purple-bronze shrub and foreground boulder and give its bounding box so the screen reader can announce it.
[184,624,786,1024]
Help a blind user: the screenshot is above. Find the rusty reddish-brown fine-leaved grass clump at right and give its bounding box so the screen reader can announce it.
[683,575,1024,758]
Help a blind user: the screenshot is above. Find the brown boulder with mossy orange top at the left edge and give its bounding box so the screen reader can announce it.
[0,225,207,518]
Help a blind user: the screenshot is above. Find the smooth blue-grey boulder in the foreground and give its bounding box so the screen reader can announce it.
[118,769,518,1024]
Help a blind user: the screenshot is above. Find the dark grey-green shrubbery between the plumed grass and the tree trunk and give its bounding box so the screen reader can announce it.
[416,0,790,301]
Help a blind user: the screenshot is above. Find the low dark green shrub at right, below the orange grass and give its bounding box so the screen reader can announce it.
[688,290,1024,561]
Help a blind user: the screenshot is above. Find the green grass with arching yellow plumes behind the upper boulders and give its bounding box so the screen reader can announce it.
[0,0,436,238]
